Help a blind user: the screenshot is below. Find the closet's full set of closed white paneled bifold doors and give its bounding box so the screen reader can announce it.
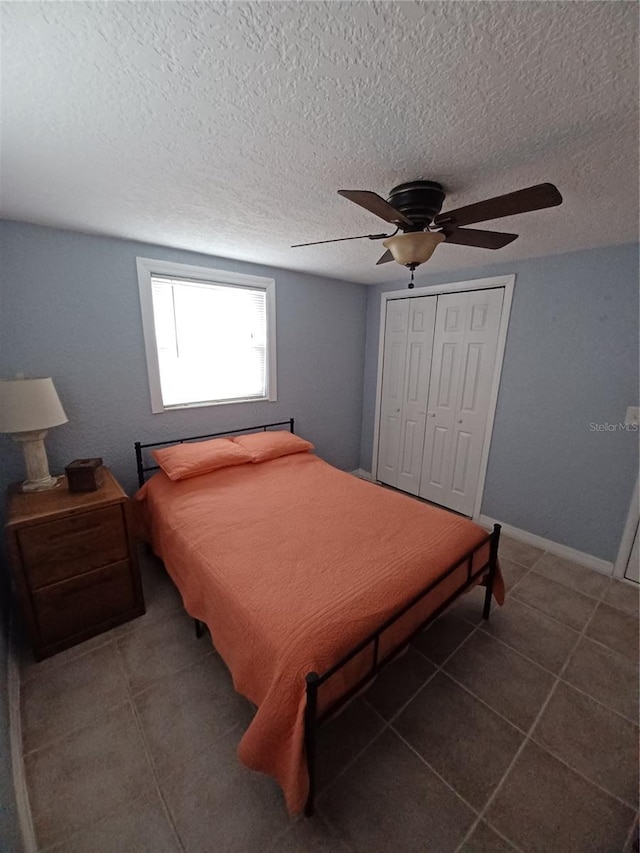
[376,287,505,515]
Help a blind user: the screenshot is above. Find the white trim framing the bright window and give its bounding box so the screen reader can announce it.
[136,258,278,414]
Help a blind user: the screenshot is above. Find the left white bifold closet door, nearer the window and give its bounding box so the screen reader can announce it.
[377,296,437,495]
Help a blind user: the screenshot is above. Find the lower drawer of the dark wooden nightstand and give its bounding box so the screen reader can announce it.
[33,560,137,645]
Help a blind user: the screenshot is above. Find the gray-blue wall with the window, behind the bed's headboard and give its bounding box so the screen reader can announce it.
[0,222,367,500]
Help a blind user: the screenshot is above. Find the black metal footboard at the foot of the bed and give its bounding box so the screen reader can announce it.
[304,524,500,817]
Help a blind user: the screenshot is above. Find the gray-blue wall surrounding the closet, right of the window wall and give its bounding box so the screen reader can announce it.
[360,245,638,560]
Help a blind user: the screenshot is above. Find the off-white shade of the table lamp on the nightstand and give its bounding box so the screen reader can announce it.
[0,377,67,433]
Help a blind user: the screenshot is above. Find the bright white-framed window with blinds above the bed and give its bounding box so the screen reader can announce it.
[137,258,276,412]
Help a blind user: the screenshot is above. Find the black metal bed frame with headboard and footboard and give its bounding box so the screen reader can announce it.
[135,418,500,817]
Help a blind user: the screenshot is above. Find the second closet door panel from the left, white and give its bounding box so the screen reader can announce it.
[396,296,437,495]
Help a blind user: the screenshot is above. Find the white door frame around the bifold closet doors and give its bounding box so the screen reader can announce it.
[371,275,516,518]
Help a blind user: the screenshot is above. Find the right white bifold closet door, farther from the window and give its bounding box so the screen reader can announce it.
[419,288,504,515]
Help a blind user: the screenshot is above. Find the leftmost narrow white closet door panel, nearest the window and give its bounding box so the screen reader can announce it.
[377,299,409,486]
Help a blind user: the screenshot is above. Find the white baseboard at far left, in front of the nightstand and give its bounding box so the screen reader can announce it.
[7,610,38,853]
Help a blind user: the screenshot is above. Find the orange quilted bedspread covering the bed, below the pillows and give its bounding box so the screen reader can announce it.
[136,453,502,813]
